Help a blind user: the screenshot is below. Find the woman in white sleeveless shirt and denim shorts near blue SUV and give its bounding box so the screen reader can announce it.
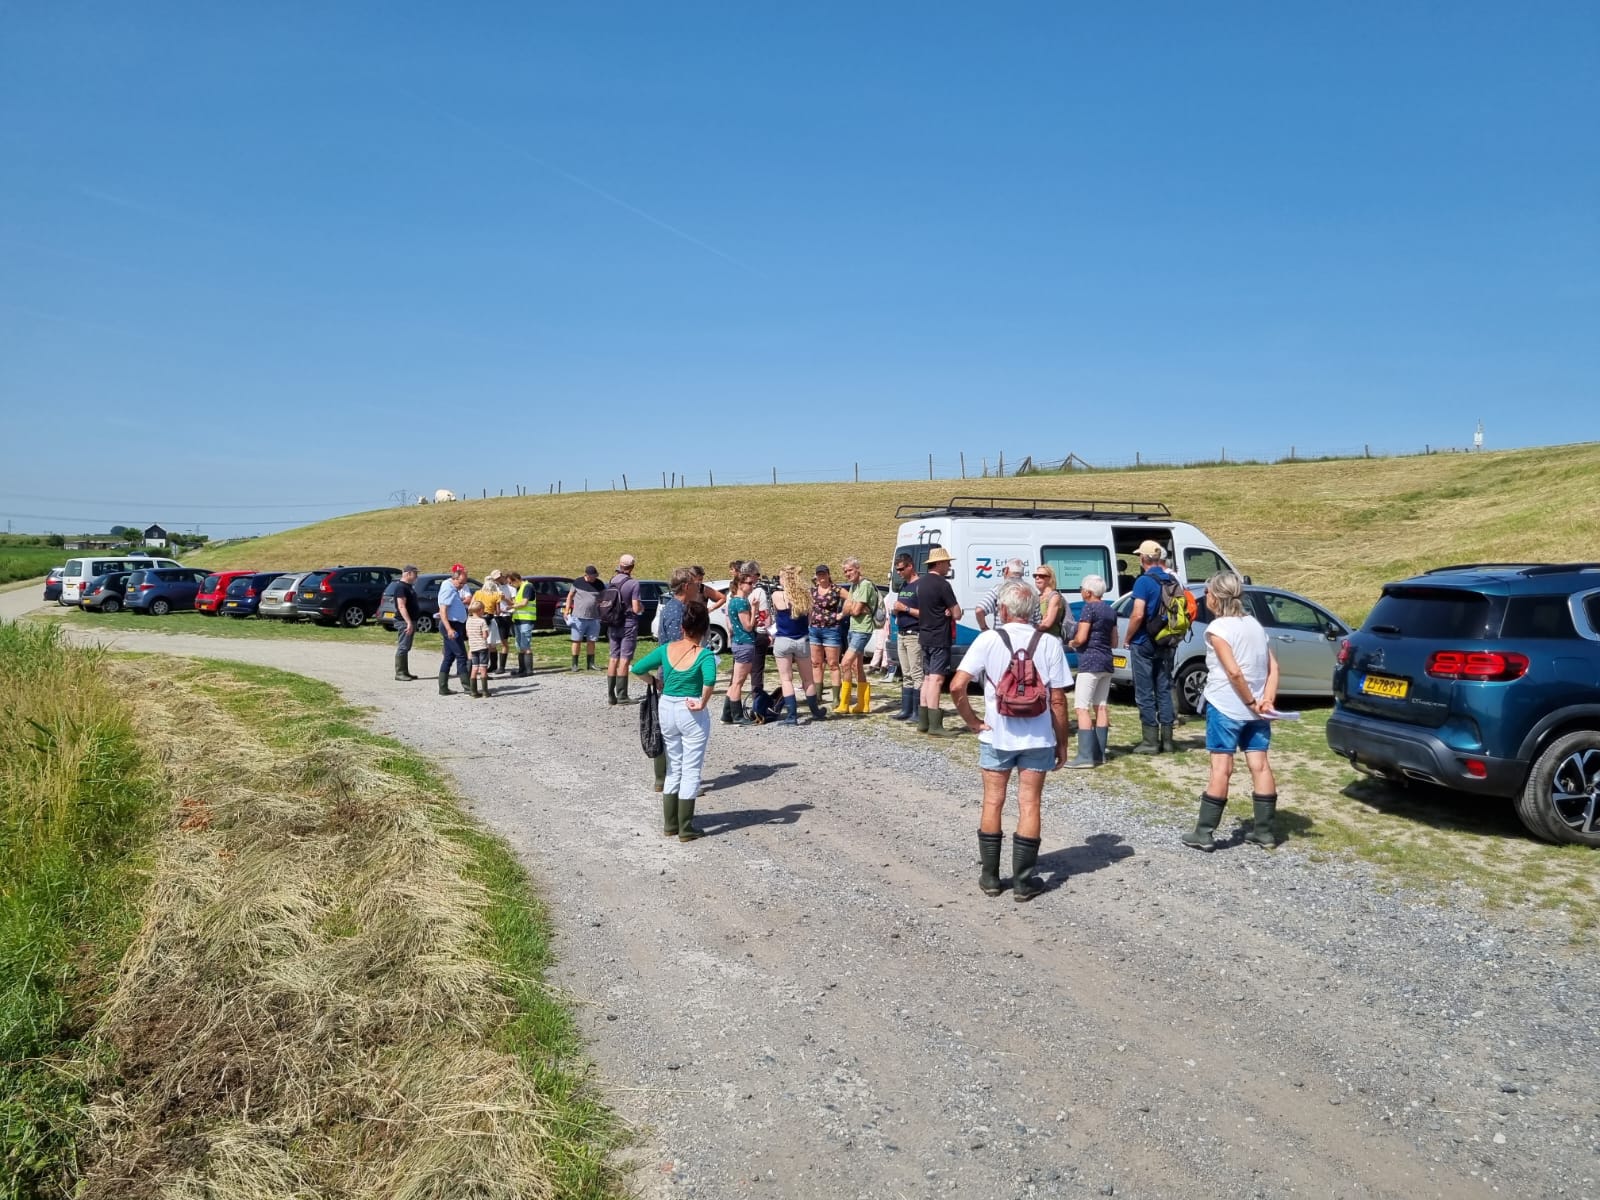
[1182,571,1278,851]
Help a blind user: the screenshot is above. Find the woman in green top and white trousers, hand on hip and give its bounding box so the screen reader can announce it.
[634,600,717,842]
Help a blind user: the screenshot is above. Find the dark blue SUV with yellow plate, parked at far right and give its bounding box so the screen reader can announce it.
[1328,563,1600,846]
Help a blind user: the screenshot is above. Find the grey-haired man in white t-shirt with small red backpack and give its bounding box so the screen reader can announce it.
[950,579,1072,901]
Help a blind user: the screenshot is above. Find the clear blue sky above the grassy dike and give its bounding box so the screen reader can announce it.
[0,0,1600,536]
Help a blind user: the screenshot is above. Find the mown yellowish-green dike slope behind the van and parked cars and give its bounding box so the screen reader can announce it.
[205,443,1600,619]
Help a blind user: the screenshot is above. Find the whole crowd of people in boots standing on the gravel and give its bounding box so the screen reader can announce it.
[387,541,1282,901]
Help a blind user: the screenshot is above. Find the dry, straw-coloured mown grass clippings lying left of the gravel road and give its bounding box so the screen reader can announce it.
[80,664,582,1200]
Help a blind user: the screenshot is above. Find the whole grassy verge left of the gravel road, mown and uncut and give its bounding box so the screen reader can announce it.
[0,627,622,1200]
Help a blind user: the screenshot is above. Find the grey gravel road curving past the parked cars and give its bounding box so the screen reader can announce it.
[9,594,1600,1200]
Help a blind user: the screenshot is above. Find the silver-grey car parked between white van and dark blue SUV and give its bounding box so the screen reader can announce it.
[1110,586,1350,712]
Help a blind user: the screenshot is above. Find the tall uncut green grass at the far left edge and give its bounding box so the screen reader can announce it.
[0,624,160,1200]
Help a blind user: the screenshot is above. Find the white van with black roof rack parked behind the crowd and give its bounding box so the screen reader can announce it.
[890,496,1234,646]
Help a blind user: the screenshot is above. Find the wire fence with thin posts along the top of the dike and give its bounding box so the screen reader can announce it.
[422,443,1474,504]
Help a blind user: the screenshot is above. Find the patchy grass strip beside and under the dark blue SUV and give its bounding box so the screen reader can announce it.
[894,684,1600,942]
